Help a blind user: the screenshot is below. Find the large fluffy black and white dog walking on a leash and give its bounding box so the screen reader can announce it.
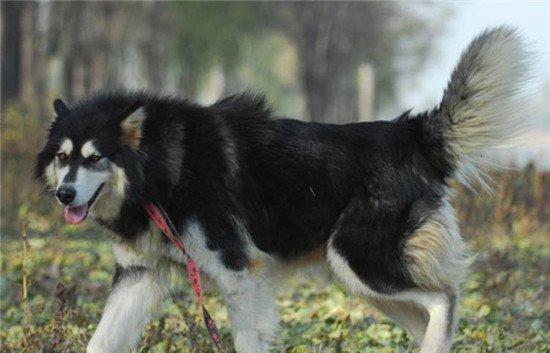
[37,27,528,353]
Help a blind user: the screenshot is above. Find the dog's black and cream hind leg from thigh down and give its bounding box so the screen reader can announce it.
[327,194,468,353]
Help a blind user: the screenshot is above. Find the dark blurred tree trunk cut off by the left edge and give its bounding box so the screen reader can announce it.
[1,1,25,105]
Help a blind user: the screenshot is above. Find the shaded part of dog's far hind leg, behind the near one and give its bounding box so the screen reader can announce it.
[368,297,429,346]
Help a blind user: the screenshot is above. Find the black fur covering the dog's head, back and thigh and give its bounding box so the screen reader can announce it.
[37,93,453,293]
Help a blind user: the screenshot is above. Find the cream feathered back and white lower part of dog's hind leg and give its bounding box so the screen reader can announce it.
[403,199,472,353]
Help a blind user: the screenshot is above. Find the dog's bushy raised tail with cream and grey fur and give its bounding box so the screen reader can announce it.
[434,26,530,190]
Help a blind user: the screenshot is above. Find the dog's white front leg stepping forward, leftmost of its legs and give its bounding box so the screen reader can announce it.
[86,245,168,353]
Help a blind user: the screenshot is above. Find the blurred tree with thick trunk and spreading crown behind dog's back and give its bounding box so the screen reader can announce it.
[257,1,442,123]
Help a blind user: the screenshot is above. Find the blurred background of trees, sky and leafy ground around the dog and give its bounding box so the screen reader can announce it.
[0,1,550,352]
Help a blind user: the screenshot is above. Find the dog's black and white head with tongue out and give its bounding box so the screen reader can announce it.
[36,99,145,224]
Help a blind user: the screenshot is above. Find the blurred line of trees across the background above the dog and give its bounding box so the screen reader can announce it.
[2,1,444,123]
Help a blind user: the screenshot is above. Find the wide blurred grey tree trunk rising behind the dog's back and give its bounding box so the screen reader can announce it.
[295,3,358,123]
